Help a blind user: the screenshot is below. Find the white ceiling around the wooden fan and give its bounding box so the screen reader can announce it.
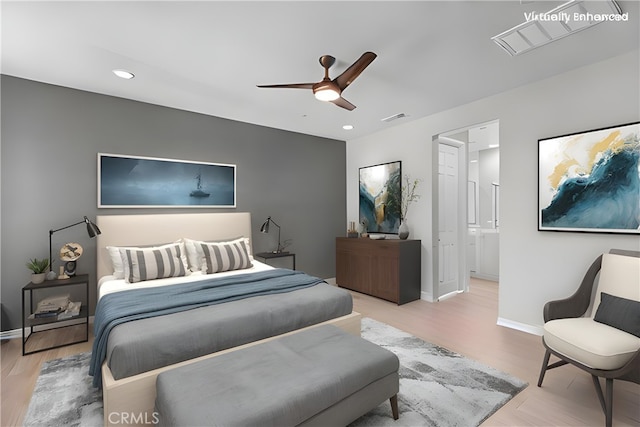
[1,0,640,140]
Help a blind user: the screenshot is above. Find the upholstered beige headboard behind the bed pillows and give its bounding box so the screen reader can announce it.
[96,212,253,279]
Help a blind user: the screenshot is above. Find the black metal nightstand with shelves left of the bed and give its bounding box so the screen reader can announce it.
[22,274,89,356]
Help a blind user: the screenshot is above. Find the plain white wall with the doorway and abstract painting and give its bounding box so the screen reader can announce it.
[345,50,640,332]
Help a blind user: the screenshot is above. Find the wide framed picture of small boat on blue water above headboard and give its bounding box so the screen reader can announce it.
[98,153,236,208]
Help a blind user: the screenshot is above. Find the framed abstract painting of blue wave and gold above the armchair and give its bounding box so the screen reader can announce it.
[538,123,640,234]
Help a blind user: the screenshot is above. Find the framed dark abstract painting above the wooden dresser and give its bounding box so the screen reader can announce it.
[358,161,402,234]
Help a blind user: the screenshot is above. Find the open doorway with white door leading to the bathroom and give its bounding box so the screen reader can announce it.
[432,120,500,301]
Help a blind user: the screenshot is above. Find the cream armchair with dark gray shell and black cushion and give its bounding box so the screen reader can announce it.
[538,249,640,427]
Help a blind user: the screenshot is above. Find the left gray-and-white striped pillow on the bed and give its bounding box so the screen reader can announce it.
[120,243,187,283]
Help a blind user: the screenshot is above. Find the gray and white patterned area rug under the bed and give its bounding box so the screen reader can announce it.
[24,318,527,427]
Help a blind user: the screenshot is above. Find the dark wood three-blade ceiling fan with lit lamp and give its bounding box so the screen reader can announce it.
[257,52,377,111]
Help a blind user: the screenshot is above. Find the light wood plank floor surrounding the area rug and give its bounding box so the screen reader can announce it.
[0,279,640,426]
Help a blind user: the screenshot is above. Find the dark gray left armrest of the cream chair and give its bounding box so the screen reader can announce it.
[543,255,602,323]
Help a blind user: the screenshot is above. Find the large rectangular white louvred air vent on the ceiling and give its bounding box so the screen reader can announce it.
[491,0,628,56]
